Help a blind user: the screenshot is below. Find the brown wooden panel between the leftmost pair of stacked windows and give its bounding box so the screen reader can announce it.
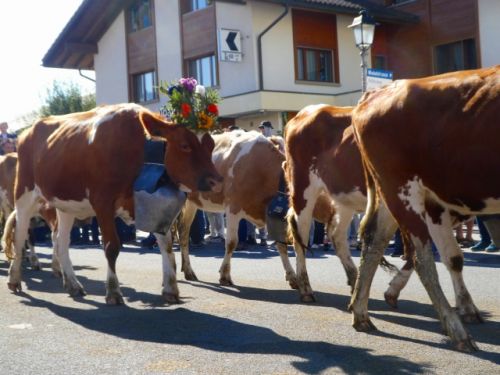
[127,27,156,74]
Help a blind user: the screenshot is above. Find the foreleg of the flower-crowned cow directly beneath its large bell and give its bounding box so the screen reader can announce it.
[155,230,180,304]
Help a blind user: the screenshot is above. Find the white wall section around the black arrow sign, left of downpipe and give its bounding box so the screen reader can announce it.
[215,2,258,96]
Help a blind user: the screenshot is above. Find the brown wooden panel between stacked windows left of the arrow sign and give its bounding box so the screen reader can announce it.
[182,6,217,59]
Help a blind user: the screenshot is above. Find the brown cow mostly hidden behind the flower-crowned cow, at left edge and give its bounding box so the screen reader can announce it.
[0,152,61,276]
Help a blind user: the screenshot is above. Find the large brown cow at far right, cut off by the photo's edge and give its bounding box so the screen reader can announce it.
[350,66,500,350]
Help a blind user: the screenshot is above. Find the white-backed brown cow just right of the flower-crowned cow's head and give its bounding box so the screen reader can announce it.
[179,131,334,288]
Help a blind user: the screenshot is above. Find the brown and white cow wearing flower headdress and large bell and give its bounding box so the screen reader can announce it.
[2,104,222,304]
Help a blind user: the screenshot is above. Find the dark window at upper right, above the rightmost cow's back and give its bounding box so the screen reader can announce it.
[435,39,477,74]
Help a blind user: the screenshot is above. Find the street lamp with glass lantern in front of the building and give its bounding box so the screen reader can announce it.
[347,9,377,93]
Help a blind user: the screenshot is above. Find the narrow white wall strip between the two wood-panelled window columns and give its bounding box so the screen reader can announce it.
[154,1,182,111]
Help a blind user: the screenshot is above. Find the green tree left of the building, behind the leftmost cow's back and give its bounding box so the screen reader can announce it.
[40,81,96,117]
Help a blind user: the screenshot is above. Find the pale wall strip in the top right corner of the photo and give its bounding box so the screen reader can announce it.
[477,0,500,67]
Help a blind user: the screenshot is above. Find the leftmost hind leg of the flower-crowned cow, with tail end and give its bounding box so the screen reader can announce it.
[3,191,36,292]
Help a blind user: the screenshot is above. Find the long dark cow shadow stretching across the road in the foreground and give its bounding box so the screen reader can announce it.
[17,294,431,374]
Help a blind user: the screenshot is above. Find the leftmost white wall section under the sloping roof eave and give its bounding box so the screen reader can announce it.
[94,12,128,105]
